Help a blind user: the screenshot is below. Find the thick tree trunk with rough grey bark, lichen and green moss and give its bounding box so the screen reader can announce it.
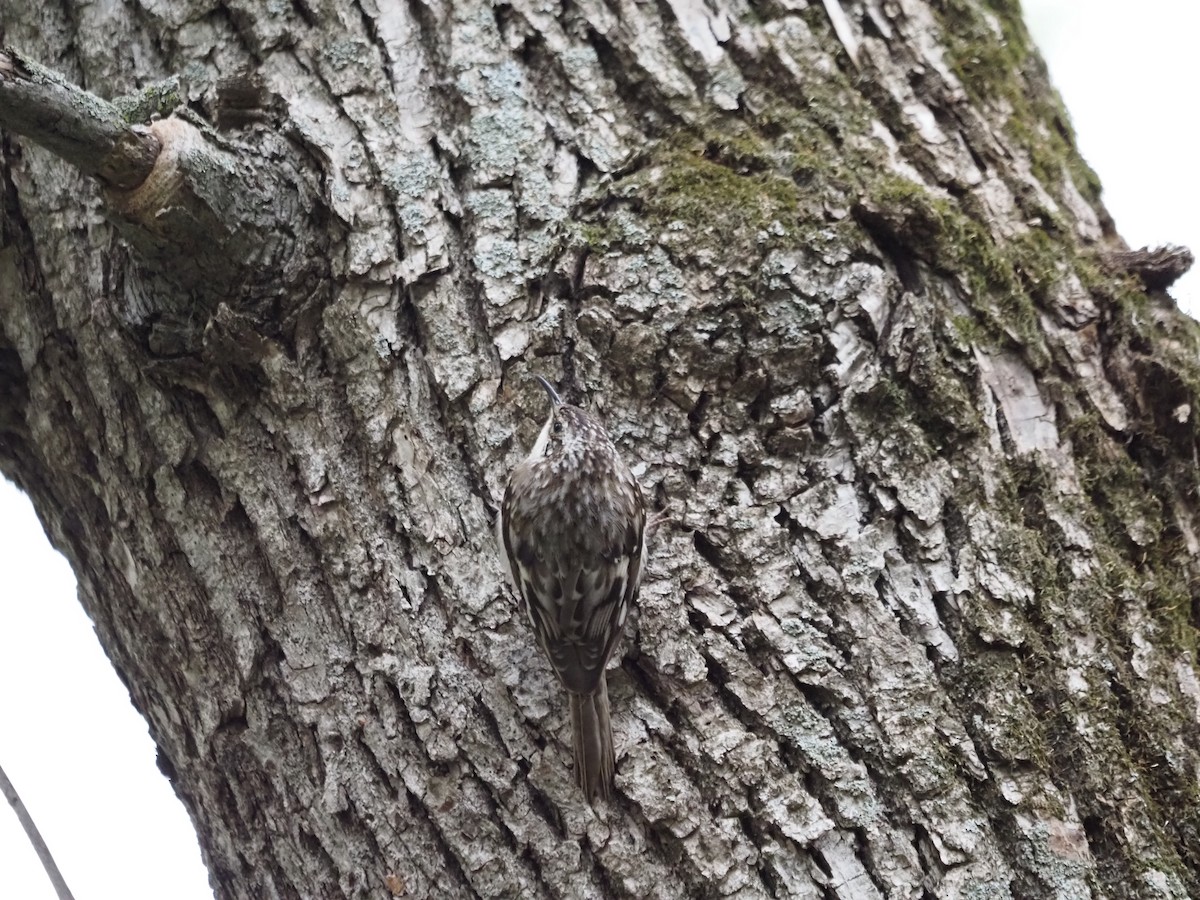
[0,0,1200,900]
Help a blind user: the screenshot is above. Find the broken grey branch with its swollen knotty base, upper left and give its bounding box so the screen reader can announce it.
[0,49,323,319]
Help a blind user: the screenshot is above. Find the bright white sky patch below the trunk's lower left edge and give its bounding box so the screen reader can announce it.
[0,478,212,900]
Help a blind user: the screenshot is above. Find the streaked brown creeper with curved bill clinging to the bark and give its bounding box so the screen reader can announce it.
[499,376,646,803]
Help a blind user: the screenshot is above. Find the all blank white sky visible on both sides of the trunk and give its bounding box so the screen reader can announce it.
[0,0,1200,900]
